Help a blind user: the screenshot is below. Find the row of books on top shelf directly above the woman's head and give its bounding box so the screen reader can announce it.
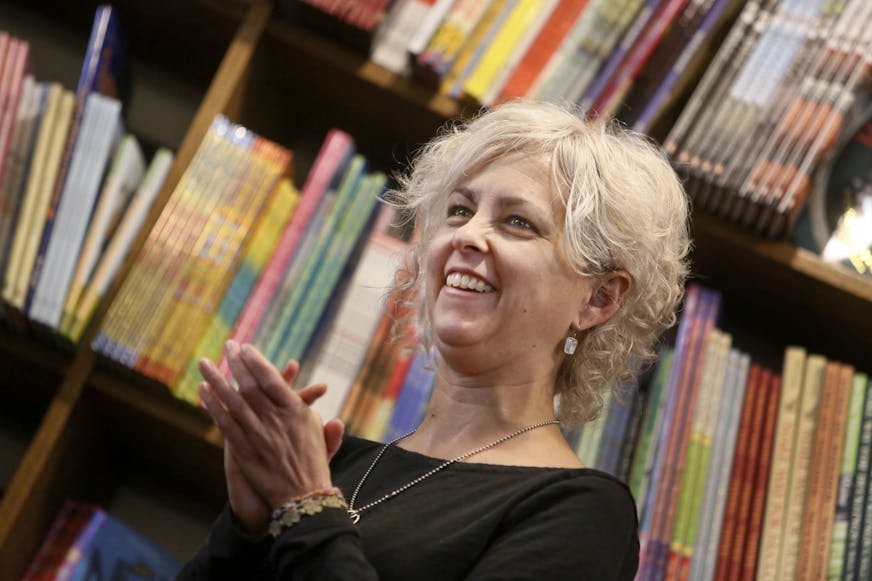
[342,0,744,131]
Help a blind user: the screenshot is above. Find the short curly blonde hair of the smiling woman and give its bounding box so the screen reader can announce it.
[392,101,690,425]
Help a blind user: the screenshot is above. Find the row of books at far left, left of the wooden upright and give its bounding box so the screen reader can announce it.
[0,6,172,340]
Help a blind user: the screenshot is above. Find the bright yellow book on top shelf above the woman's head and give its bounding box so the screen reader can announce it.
[463,0,553,103]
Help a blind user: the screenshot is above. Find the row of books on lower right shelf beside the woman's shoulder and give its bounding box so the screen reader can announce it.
[568,285,872,581]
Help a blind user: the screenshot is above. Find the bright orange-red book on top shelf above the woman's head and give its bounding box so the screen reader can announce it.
[498,0,588,102]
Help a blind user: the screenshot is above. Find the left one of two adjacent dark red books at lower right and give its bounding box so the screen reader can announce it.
[715,363,765,581]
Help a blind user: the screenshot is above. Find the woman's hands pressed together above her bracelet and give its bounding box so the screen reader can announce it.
[199,341,343,536]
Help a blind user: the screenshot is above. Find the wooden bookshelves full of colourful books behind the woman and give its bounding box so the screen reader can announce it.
[0,0,872,580]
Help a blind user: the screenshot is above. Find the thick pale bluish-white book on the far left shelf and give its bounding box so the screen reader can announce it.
[29,93,121,327]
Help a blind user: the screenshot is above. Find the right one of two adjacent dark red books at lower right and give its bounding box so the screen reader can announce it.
[740,370,781,579]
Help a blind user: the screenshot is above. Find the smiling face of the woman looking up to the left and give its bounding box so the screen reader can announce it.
[426,154,592,379]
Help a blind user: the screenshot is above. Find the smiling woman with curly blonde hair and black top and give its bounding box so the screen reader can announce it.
[180,102,688,580]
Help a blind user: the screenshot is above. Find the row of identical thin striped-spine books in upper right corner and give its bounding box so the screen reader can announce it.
[665,0,872,237]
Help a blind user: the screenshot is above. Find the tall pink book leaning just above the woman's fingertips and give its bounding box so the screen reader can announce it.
[218,129,354,377]
